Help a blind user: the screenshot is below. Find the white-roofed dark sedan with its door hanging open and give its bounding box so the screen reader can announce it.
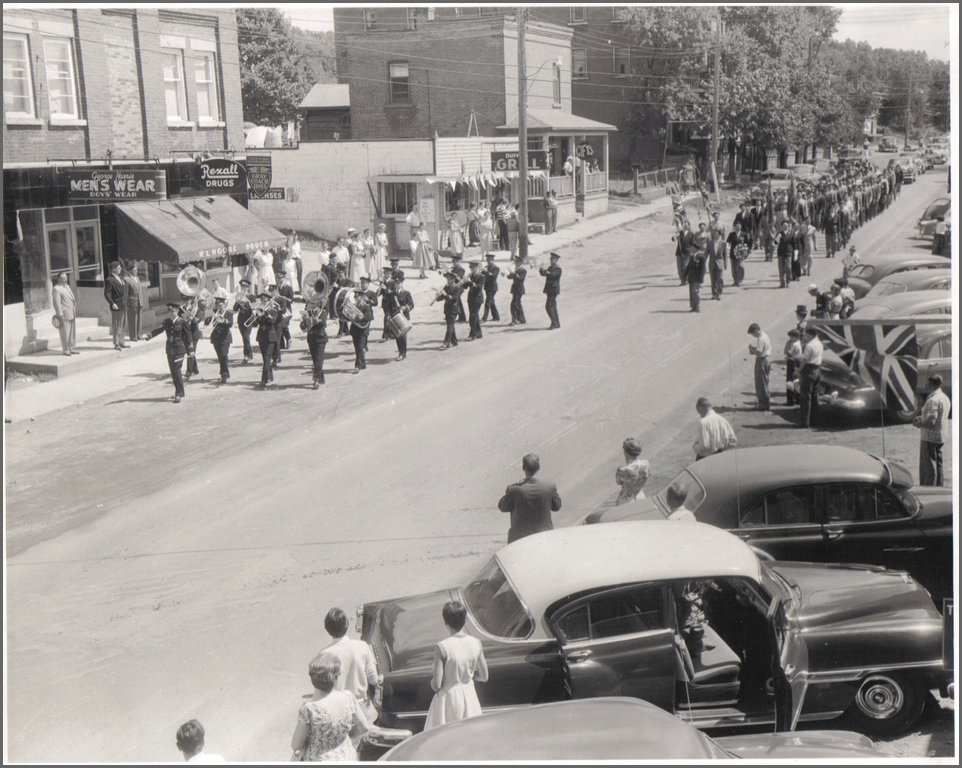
[358,520,950,734]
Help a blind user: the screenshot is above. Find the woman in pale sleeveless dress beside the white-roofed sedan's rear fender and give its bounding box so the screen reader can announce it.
[424,600,488,730]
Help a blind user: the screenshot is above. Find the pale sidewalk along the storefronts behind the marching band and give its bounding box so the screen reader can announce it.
[3,196,671,423]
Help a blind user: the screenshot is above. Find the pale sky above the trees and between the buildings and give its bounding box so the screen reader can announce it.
[282,3,951,61]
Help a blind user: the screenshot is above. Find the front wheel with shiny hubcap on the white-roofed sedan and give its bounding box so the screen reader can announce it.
[846,672,926,737]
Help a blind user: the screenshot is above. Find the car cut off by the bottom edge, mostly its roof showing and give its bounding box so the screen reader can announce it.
[381,696,884,764]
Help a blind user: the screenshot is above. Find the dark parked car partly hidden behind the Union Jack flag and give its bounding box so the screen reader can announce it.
[819,323,953,424]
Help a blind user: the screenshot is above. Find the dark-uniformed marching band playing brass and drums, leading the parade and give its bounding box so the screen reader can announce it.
[163,253,561,402]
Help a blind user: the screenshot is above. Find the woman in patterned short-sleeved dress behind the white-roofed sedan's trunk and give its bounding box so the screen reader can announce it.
[291,652,381,763]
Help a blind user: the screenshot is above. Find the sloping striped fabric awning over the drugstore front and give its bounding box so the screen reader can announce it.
[117,196,287,264]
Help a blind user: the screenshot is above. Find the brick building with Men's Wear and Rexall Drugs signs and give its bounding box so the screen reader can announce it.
[3,7,277,355]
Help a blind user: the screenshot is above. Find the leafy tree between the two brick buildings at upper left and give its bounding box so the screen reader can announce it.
[235,8,313,125]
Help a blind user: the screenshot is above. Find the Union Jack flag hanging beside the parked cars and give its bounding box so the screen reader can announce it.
[809,318,919,411]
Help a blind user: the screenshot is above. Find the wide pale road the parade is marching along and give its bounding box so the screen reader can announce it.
[6,174,944,761]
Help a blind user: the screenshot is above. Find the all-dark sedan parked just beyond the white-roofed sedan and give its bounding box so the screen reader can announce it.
[584,445,952,599]
